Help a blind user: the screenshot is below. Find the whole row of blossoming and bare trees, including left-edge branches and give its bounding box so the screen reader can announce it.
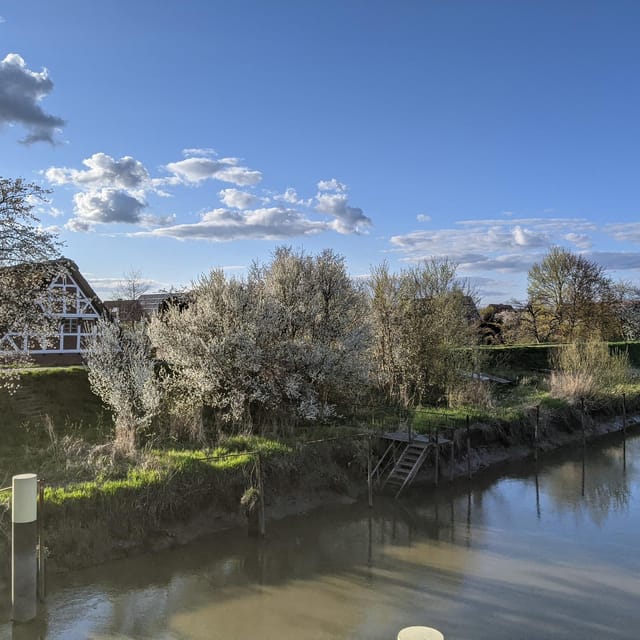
[0,179,640,448]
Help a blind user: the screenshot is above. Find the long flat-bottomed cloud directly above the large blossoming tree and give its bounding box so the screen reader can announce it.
[138,207,329,242]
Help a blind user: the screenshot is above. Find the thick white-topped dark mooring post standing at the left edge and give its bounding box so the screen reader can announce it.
[11,473,38,622]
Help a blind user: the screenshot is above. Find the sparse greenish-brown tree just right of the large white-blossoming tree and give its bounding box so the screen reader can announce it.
[370,259,477,405]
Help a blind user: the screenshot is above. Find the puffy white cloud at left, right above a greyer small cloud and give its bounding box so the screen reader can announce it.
[44,153,150,191]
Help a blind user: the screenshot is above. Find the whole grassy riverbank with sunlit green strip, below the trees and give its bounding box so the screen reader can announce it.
[0,360,640,572]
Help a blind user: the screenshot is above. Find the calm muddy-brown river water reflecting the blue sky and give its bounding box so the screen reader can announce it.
[0,436,640,640]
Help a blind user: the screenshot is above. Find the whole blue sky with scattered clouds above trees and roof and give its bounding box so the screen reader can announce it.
[0,0,640,303]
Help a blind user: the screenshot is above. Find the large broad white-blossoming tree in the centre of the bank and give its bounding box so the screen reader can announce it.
[150,247,368,428]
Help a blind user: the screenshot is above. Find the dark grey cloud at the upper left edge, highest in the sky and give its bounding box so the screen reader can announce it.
[0,53,65,145]
